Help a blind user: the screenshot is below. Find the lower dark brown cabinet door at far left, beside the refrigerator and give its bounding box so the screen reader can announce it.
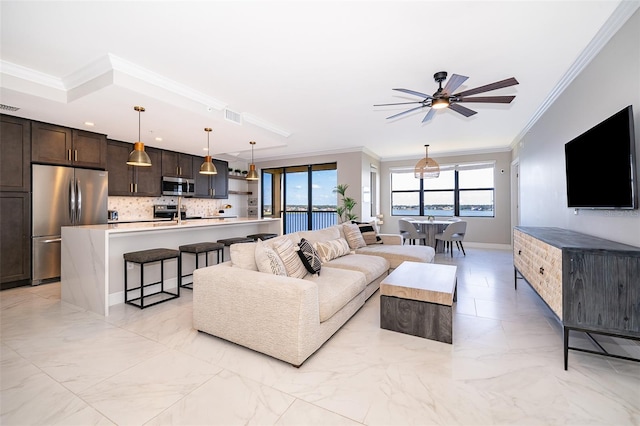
[0,192,31,289]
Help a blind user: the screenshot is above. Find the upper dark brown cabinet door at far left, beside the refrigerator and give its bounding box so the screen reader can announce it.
[0,115,31,192]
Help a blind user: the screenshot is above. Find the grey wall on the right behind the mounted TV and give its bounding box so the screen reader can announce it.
[513,11,640,246]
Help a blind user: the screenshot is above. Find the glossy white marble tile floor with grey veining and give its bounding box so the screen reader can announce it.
[0,248,640,426]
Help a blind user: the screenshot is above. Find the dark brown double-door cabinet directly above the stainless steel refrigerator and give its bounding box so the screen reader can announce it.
[31,121,107,170]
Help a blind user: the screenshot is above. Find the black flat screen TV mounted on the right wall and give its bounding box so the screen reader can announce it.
[564,105,638,209]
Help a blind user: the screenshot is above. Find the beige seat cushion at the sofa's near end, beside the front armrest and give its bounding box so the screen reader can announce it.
[305,268,367,322]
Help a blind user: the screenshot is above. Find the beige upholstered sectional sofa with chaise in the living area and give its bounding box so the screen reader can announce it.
[193,225,435,366]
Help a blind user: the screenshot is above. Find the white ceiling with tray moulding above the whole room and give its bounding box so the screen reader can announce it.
[0,0,638,161]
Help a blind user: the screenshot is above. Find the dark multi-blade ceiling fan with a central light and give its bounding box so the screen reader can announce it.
[374,71,518,123]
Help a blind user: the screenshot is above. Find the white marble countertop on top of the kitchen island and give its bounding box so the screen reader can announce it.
[72,217,280,234]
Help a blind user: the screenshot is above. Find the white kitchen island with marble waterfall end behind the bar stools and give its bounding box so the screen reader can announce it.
[60,218,282,316]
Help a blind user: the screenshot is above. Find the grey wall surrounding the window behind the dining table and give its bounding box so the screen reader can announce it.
[380,152,511,246]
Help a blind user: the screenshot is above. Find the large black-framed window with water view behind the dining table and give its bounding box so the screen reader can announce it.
[391,162,495,217]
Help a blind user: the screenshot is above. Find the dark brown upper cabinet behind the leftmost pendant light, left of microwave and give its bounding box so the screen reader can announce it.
[107,140,162,197]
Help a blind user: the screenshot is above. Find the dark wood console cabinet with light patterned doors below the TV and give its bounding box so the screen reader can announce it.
[513,226,640,370]
